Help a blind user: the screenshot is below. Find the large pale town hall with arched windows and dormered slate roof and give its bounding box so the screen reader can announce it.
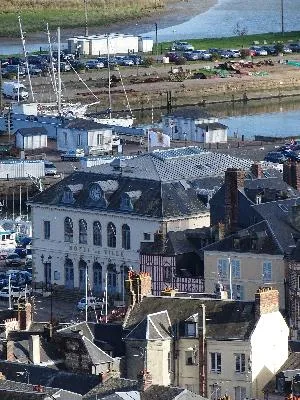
[31,147,251,297]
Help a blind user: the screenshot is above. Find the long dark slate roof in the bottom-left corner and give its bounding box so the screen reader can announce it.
[0,360,99,395]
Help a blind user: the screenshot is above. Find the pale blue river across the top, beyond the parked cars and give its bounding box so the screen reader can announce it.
[0,0,300,55]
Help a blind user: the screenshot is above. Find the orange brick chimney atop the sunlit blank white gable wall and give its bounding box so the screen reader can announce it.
[255,287,279,320]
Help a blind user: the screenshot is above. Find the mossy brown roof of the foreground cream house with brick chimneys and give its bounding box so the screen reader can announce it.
[125,296,255,340]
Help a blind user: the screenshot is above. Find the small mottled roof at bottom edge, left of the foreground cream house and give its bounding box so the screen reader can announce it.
[83,378,138,400]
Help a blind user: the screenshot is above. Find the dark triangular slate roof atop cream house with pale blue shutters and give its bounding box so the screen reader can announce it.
[203,221,283,255]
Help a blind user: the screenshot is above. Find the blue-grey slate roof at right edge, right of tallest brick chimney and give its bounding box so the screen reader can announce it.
[252,198,300,253]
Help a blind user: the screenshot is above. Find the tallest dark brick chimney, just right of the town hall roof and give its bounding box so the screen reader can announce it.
[225,168,245,233]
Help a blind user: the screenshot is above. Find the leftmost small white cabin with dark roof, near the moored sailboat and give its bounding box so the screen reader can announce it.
[15,127,48,150]
